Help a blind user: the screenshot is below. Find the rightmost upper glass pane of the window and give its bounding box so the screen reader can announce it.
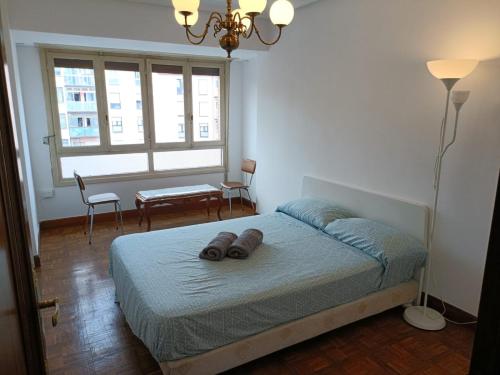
[192,68,221,142]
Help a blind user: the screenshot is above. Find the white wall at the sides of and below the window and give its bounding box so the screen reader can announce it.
[17,45,245,221]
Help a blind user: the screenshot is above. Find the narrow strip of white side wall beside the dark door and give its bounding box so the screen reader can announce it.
[0,0,40,255]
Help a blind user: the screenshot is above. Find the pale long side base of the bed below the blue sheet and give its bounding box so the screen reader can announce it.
[160,280,418,375]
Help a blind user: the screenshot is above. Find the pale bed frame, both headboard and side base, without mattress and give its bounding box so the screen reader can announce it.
[160,176,428,375]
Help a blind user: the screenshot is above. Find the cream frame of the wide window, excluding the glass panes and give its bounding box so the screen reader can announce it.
[40,47,229,186]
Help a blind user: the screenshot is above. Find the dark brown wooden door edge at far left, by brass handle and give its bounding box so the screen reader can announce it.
[0,28,45,374]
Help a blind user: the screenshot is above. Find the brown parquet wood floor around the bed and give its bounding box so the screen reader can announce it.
[37,208,474,375]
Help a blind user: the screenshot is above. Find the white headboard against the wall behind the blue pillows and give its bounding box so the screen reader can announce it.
[302,176,429,244]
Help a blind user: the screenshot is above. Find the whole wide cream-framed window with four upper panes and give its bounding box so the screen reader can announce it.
[43,50,227,185]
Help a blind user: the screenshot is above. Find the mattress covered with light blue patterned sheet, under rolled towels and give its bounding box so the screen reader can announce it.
[110,213,421,362]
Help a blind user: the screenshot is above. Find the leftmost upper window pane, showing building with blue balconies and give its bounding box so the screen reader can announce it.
[54,59,100,147]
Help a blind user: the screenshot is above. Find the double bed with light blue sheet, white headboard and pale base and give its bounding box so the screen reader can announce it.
[110,177,427,374]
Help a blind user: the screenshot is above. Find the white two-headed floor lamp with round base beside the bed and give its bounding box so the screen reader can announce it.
[403,60,479,331]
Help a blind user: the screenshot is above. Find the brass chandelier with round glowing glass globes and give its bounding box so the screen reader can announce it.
[172,0,294,58]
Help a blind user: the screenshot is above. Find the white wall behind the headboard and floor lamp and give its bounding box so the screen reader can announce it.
[243,0,500,314]
